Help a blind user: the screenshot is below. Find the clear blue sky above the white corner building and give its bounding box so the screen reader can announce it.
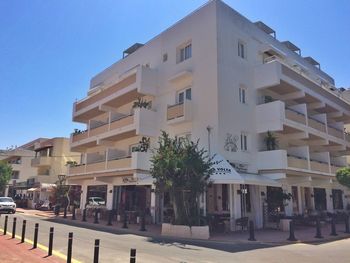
[0,0,350,149]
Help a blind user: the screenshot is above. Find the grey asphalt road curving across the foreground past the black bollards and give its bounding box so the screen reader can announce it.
[0,214,350,263]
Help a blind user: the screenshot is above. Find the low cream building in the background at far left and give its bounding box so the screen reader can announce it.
[0,137,80,207]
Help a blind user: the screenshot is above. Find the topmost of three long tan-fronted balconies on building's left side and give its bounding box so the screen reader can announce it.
[73,66,157,123]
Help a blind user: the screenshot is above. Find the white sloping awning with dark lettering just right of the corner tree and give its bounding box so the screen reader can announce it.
[210,154,244,184]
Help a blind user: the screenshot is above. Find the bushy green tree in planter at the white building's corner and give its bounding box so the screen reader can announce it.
[151,131,214,226]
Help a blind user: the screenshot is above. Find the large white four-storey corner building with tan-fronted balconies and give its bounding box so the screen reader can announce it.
[69,1,350,228]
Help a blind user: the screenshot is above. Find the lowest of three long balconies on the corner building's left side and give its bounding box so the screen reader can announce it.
[69,152,151,176]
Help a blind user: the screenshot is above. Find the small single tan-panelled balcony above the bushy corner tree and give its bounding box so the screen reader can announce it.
[167,100,192,125]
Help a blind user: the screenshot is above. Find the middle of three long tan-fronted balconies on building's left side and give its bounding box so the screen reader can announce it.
[71,108,157,151]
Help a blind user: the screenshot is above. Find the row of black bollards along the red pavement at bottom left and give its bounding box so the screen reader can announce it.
[3,216,136,263]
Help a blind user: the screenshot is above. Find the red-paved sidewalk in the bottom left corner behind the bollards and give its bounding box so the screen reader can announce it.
[0,235,64,263]
